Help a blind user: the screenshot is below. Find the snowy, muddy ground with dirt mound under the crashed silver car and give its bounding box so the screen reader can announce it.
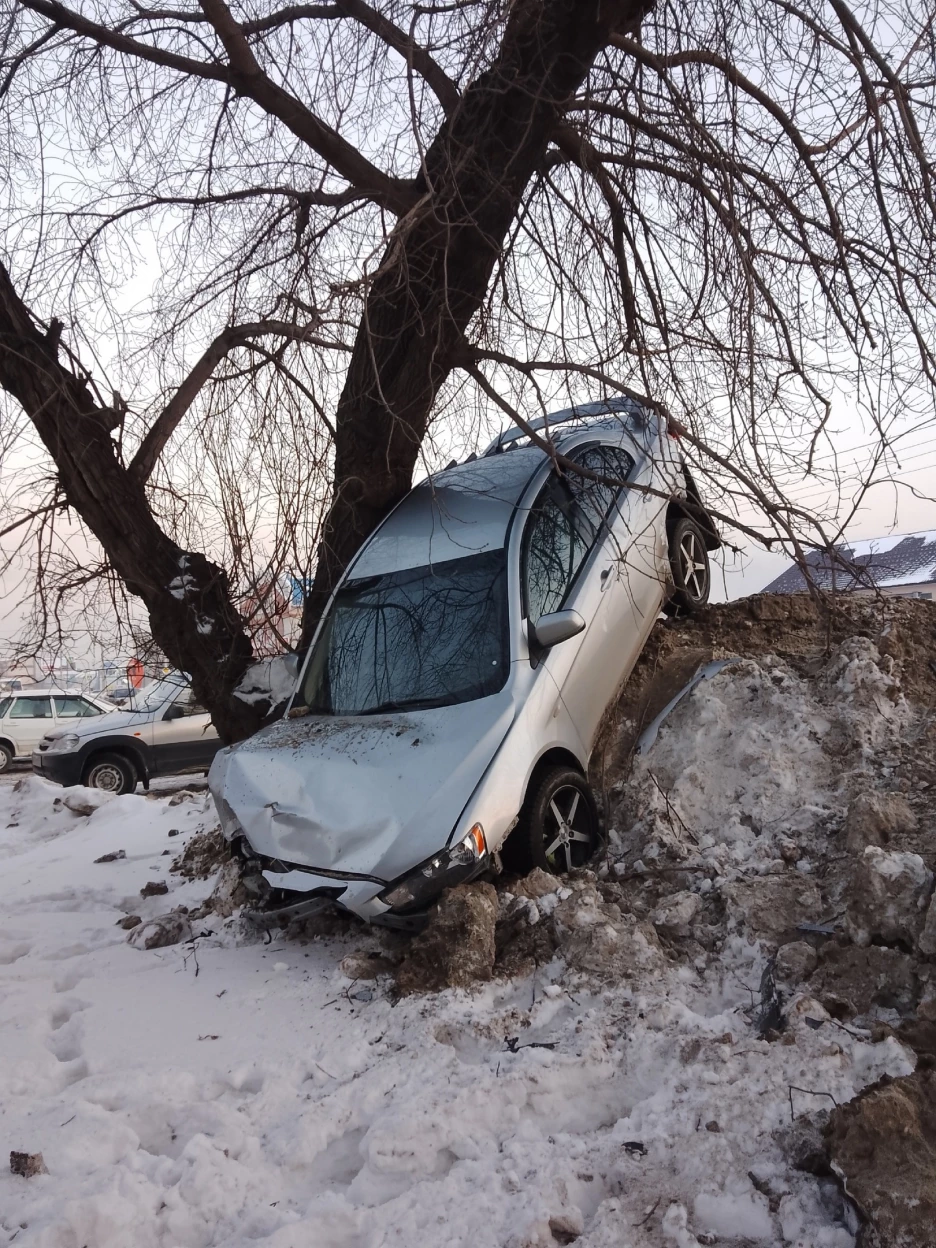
[0,605,936,1248]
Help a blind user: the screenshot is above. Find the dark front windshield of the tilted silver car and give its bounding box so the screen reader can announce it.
[297,550,509,715]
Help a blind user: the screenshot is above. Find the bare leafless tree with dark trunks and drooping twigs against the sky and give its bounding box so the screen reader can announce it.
[0,0,936,739]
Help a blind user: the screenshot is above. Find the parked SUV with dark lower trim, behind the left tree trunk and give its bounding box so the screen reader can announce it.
[32,674,221,792]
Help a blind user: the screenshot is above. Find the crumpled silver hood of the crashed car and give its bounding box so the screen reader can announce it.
[208,691,514,881]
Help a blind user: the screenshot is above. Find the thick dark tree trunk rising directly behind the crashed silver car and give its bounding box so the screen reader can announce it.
[302,0,651,644]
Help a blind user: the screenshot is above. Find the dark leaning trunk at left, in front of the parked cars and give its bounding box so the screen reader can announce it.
[0,257,262,741]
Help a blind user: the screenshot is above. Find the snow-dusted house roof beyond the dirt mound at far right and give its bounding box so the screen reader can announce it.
[763,529,936,594]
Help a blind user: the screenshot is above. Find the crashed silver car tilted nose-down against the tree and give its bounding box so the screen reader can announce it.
[208,399,720,927]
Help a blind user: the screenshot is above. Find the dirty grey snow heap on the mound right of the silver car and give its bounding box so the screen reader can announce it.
[612,638,914,888]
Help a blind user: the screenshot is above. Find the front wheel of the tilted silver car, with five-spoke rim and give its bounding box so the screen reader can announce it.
[500,766,604,875]
